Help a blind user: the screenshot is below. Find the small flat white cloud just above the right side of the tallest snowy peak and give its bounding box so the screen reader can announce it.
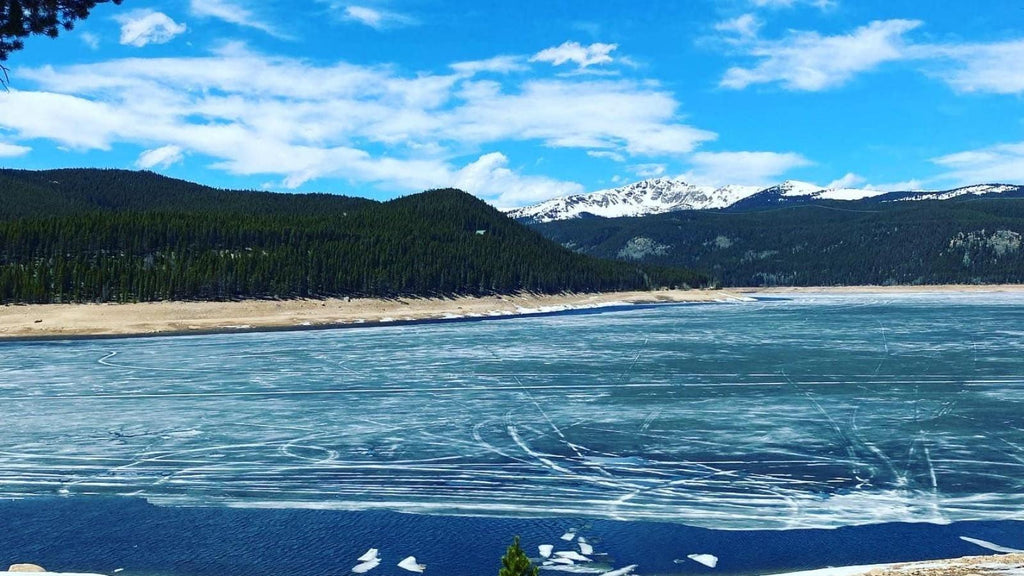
[682,152,812,186]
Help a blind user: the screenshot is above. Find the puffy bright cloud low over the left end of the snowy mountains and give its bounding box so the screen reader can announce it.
[455,152,584,208]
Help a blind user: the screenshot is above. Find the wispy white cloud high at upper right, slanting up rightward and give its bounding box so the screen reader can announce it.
[720,19,922,91]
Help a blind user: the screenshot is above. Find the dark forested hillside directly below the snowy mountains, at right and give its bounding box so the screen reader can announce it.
[535,198,1024,286]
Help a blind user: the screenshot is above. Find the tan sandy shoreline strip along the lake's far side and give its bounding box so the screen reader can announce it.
[0,284,1024,342]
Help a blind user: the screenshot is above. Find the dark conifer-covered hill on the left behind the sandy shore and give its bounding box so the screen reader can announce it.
[0,170,708,302]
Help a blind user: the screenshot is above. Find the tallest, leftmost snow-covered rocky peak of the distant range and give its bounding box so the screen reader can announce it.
[508,178,760,222]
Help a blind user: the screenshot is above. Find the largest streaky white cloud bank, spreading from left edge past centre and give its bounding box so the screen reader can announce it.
[0,45,715,205]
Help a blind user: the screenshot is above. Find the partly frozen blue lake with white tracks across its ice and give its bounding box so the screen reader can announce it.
[0,294,1024,575]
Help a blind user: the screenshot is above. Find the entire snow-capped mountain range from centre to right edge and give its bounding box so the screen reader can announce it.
[508,178,1024,222]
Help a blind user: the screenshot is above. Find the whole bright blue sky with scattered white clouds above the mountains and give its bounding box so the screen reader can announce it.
[0,0,1024,207]
